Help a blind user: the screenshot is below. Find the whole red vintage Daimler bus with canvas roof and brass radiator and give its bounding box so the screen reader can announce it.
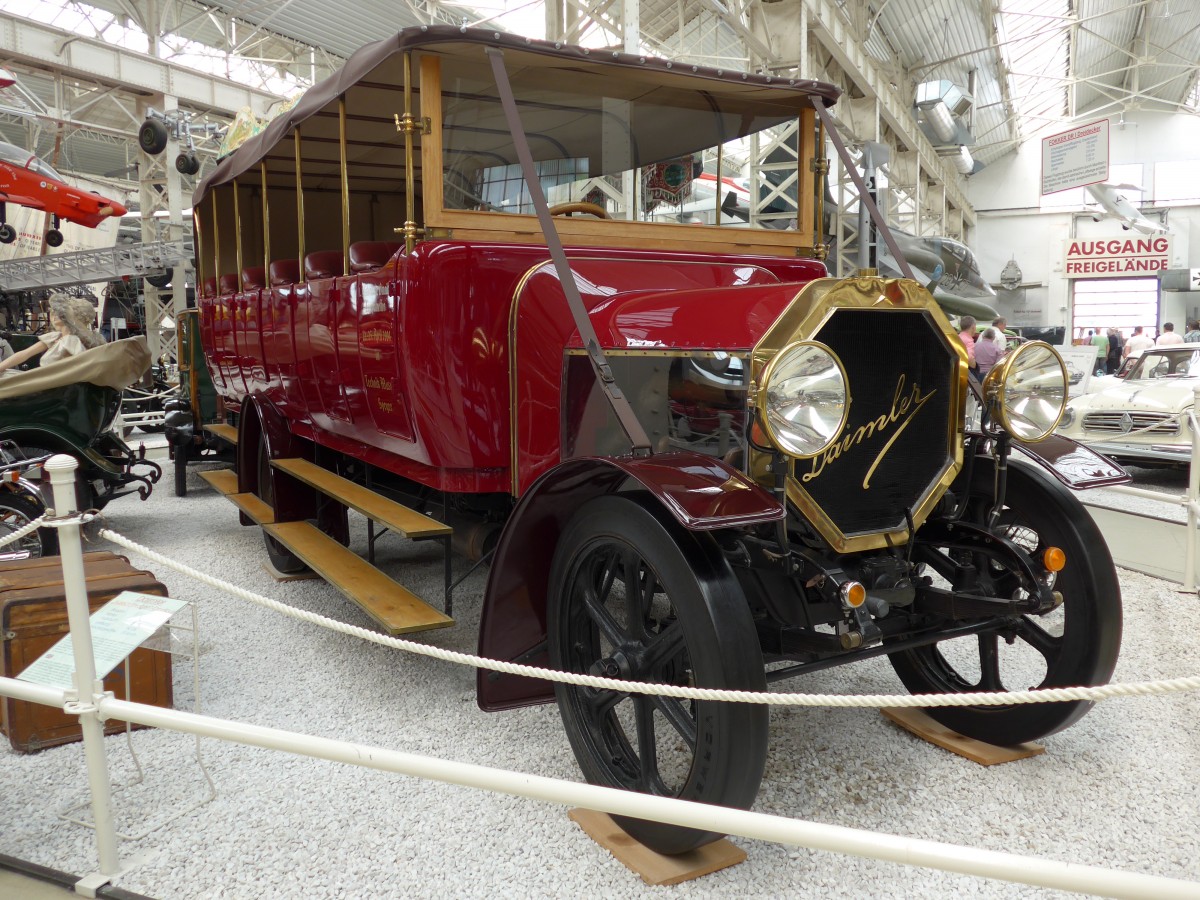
[187,28,1124,853]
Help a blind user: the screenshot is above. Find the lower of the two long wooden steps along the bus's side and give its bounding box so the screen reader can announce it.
[263,522,454,635]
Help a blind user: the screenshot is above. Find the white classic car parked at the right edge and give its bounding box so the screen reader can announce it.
[1058,343,1200,466]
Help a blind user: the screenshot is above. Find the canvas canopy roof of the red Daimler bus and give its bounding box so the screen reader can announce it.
[193,26,839,204]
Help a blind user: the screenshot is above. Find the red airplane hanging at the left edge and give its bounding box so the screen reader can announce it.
[0,142,126,247]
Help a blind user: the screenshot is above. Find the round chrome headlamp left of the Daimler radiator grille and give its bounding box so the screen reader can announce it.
[757,341,850,458]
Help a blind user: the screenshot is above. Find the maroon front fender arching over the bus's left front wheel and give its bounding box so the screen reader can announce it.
[476,452,785,710]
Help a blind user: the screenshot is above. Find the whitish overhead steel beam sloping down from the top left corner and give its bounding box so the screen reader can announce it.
[0,12,280,118]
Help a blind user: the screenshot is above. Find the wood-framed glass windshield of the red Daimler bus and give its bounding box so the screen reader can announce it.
[442,54,798,229]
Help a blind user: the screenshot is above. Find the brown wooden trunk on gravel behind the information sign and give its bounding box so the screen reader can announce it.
[0,552,172,752]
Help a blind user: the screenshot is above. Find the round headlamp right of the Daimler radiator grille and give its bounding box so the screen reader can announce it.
[984,341,1067,442]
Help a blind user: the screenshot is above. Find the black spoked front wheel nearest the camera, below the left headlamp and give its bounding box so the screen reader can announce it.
[547,497,768,854]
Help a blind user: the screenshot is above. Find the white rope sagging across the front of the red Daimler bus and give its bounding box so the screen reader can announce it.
[100,528,1200,709]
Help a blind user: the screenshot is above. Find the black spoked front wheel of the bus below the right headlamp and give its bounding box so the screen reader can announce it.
[890,464,1121,744]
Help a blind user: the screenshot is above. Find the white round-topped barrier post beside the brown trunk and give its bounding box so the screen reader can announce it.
[46,454,120,875]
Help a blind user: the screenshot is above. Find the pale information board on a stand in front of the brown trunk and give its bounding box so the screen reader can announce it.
[17,590,187,689]
